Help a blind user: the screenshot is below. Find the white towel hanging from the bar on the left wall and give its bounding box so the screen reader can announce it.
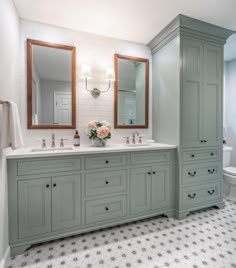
[1,102,24,149]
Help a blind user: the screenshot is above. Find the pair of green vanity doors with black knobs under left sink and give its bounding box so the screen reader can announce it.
[18,175,81,238]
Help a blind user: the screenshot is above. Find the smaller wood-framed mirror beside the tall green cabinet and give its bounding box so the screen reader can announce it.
[114,54,149,128]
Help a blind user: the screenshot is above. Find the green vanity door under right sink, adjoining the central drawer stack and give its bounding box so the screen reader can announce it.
[130,167,151,214]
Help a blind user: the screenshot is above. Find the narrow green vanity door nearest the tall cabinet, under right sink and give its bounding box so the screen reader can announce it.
[152,166,171,210]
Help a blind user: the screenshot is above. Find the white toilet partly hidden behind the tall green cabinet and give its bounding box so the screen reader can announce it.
[223,146,236,202]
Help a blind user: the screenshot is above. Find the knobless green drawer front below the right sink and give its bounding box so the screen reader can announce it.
[130,151,171,164]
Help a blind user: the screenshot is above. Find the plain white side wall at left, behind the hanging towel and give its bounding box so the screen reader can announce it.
[0,0,20,267]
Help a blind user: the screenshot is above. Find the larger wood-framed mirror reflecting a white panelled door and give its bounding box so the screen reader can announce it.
[27,39,76,129]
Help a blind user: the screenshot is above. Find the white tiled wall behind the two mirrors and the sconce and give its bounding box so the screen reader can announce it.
[19,20,152,146]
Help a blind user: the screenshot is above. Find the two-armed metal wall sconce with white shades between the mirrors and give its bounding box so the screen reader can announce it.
[81,64,115,98]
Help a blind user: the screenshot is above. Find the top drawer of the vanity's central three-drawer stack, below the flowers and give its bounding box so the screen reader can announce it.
[85,154,127,169]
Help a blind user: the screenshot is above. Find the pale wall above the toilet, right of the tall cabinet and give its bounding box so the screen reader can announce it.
[224,59,236,167]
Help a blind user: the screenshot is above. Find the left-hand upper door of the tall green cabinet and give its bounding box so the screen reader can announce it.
[182,39,203,148]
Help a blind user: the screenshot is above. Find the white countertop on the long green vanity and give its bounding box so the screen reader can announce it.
[6,143,176,159]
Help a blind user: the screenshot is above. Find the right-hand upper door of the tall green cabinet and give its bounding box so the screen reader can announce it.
[203,44,223,146]
